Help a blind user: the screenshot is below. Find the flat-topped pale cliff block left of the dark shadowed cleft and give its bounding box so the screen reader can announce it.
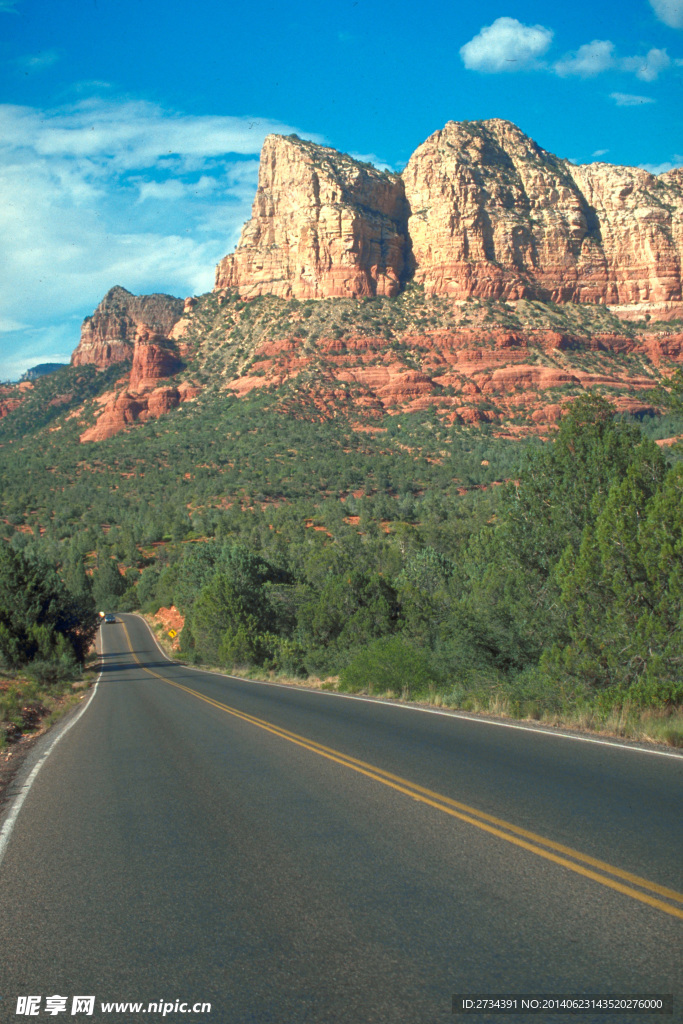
[216,135,410,299]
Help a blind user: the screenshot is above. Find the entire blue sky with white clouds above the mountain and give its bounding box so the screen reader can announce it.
[0,0,683,380]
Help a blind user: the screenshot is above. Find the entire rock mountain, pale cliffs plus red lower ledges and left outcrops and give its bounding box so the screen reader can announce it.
[14,120,683,441]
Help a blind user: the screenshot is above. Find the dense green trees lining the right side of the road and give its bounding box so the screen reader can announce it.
[131,397,683,707]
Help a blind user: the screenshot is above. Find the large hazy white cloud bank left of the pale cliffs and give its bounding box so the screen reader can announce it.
[0,98,319,377]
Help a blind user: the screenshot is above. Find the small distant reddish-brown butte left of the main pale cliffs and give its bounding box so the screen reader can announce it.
[71,285,183,370]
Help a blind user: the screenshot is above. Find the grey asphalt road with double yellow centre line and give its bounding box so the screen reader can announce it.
[0,615,683,1024]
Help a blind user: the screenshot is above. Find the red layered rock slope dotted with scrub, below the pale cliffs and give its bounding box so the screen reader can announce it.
[147,286,683,434]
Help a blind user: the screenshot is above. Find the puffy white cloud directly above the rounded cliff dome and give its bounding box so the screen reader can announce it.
[460,17,553,72]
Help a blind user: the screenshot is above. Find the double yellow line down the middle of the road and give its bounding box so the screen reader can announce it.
[122,624,683,920]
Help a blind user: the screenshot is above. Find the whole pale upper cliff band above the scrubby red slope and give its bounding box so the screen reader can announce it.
[216,119,683,305]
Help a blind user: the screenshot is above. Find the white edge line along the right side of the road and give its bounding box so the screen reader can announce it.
[131,612,683,761]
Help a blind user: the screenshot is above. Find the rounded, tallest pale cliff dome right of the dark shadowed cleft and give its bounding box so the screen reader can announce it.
[403,120,605,301]
